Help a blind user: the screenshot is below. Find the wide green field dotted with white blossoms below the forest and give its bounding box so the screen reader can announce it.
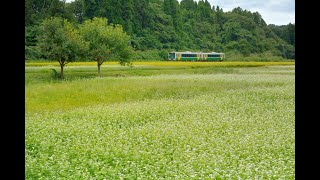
[25,62,295,179]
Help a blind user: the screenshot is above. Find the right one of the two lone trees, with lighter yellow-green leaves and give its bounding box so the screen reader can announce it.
[80,17,131,77]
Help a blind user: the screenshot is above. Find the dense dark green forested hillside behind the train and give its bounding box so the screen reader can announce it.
[25,0,295,59]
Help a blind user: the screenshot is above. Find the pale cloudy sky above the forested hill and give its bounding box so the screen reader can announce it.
[66,0,295,25]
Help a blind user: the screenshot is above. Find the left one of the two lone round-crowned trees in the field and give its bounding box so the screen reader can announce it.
[37,17,87,78]
